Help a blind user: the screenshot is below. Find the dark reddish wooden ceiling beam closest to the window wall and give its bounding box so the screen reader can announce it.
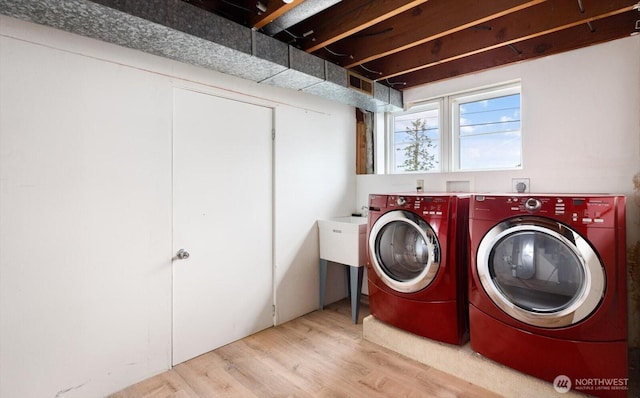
[393,12,638,89]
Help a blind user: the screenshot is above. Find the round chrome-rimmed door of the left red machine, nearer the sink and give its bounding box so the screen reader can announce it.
[369,210,440,293]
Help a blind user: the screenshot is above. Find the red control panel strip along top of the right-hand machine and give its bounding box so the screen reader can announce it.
[469,195,624,228]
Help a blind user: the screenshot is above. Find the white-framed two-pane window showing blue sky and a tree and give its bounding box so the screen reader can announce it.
[389,84,522,173]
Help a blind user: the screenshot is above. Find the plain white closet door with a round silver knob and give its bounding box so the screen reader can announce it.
[173,89,273,365]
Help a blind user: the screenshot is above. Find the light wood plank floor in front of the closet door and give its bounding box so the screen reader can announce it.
[111,300,498,398]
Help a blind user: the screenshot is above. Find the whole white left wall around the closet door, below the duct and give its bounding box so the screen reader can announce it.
[0,16,355,398]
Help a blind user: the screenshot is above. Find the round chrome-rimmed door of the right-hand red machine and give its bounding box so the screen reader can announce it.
[476,217,606,328]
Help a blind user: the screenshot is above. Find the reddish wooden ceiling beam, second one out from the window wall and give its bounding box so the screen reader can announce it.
[368,0,636,79]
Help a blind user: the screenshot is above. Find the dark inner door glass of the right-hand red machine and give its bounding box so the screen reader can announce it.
[489,231,585,313]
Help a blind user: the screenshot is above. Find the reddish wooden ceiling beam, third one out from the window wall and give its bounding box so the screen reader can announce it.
[324,0,545,68]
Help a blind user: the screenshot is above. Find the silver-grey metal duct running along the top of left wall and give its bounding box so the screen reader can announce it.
[0,0,402,112]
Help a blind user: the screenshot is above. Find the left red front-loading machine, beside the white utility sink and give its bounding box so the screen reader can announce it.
[367,193,469,345]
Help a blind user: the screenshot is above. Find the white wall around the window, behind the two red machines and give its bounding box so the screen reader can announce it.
[357,36,640,347]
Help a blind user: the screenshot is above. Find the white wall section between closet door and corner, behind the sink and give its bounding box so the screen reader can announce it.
[275,107,355,323]
